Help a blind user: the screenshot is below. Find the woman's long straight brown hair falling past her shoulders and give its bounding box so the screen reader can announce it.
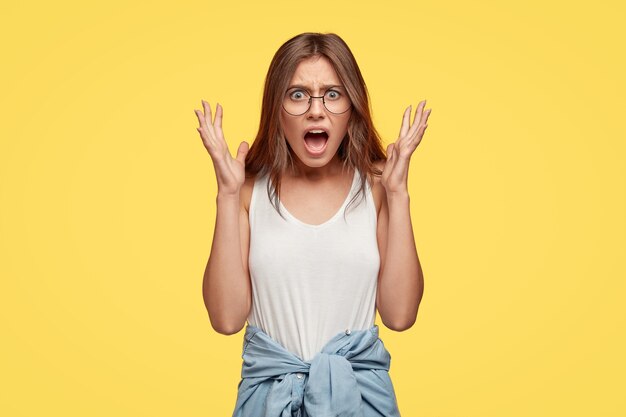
[246,32,387,216]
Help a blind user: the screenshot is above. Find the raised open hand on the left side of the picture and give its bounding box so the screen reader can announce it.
[194,100,249,195]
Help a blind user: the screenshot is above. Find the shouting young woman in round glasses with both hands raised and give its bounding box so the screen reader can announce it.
[196,33,430,417]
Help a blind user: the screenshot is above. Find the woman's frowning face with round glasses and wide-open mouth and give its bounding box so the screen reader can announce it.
[280,56,352,172]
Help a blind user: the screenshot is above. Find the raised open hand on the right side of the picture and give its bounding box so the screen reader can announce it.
[381,100,432,195]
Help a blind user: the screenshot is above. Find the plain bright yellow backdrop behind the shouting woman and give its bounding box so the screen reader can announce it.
[0,0,626,417]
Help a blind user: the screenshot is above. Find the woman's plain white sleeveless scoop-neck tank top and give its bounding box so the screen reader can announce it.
[248,170,380,361]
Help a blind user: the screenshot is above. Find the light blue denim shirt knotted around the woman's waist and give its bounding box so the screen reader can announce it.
[233,324,400,417]
